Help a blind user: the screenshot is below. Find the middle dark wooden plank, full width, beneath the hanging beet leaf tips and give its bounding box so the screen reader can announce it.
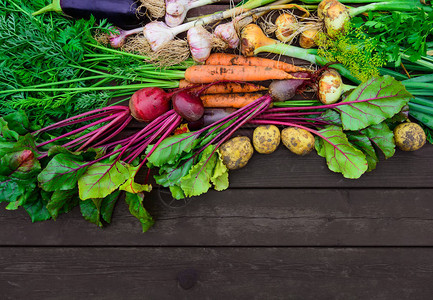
[0,189,433,246]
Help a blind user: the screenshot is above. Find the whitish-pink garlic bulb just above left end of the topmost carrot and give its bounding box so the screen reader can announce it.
[187,26,212,62]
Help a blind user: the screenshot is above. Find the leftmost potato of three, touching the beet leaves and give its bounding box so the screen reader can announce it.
[219,136,254,170]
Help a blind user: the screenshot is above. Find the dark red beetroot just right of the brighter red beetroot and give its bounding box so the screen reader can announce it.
[171,91,204,122]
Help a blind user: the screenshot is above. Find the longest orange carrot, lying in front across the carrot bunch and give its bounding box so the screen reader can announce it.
[185,65,306,83]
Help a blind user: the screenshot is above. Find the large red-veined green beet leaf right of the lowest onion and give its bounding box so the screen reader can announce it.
[337,75,413,130]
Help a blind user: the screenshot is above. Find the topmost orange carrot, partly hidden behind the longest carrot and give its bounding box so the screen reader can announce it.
[206,53,307,73]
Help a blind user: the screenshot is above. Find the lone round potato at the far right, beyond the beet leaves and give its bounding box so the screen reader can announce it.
[394,123,426,151]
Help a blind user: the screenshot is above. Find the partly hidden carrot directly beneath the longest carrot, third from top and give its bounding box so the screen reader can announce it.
[179,79,267,95]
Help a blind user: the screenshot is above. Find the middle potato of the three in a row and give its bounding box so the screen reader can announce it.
[253,125,280,154]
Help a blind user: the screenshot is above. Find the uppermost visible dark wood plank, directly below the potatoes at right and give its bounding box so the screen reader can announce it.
[224,145,433,188]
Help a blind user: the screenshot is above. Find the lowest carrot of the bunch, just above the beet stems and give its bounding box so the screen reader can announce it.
[200,93,264,108]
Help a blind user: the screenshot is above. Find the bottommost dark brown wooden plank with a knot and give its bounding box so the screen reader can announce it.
[0,248,433,300]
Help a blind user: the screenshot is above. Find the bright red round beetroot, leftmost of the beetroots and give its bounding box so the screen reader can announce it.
[129,87,171,122]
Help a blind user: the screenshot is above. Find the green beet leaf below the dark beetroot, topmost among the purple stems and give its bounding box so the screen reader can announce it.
[146,132,197,167]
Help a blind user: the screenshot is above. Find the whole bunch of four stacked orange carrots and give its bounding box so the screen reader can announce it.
[179,53,306,108]
